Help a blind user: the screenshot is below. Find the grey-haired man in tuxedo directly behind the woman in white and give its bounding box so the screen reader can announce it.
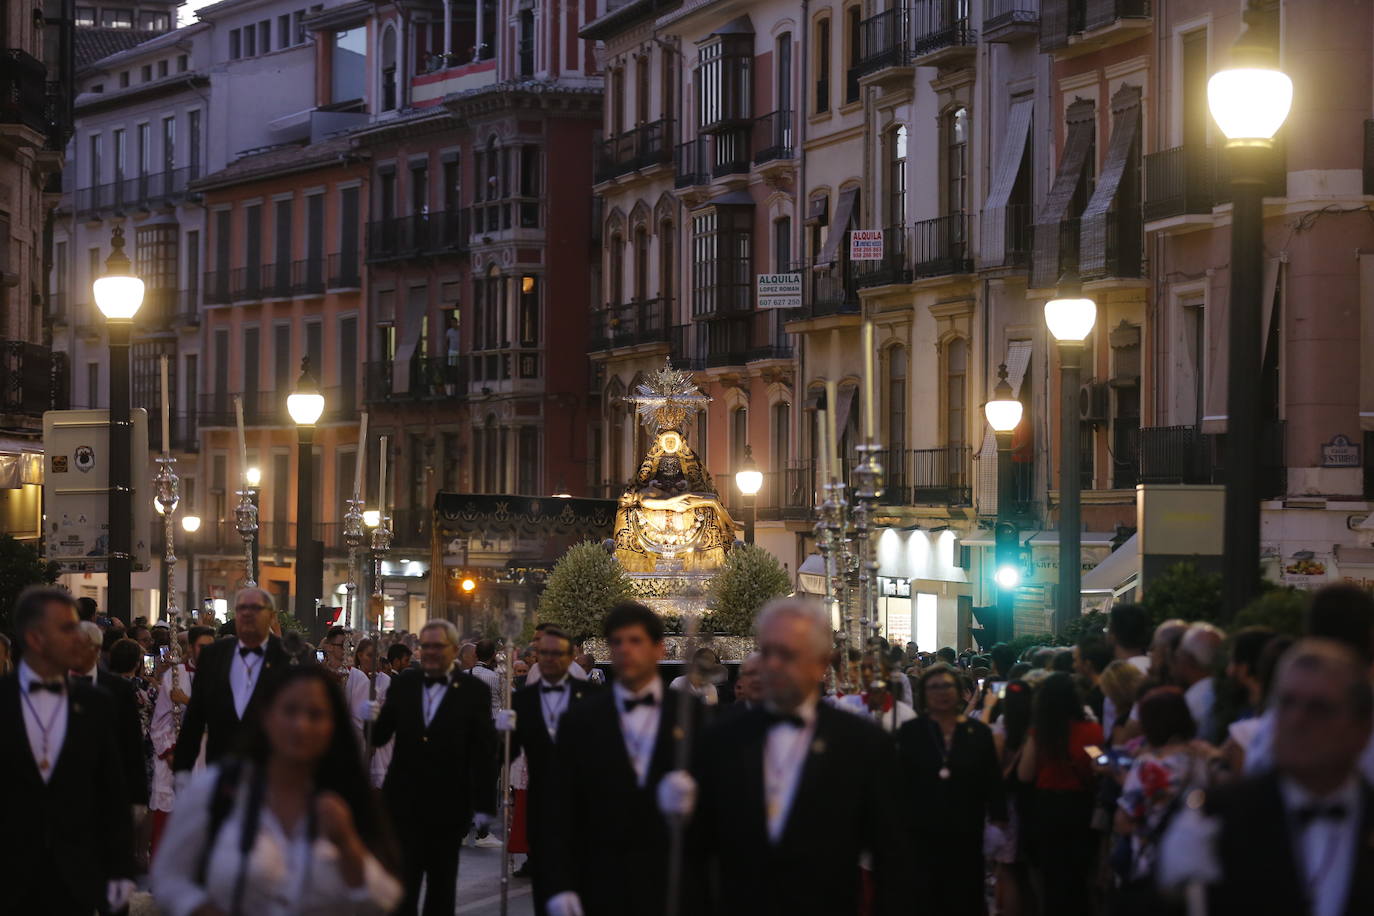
[172,588,290,774]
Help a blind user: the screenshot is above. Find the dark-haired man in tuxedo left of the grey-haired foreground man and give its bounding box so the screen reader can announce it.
[547,602,699,916]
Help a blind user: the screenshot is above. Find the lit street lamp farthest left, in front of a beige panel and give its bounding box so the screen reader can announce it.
[92,225,143,626]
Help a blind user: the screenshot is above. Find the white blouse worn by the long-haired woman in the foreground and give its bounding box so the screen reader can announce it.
[151,766,404,916]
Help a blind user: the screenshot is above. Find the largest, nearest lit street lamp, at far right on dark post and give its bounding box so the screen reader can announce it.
[1206,0,1293,619]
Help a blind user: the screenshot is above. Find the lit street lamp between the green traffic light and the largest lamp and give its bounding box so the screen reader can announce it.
[1044,269,1098,633]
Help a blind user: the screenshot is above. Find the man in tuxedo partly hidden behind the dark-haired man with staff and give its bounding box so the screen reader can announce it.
[511,628,598,913]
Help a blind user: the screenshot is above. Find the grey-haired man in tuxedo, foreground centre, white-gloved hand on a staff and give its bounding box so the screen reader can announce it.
[684,599,911,916]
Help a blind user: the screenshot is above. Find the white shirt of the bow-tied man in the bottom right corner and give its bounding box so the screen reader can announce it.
[1279,777,1363,916]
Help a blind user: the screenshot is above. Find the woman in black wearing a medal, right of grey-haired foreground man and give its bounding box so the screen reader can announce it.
[897,663,1007,916]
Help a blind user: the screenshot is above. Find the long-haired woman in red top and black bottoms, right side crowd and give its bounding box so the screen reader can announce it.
[1017,672,1103,916]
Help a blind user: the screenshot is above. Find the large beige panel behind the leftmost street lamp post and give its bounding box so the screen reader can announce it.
[43,408,153,573]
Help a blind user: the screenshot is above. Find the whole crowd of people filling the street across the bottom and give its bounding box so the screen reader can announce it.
[0,586,1374,916]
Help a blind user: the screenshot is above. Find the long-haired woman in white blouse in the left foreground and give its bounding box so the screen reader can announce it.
[151,665,404,916]
